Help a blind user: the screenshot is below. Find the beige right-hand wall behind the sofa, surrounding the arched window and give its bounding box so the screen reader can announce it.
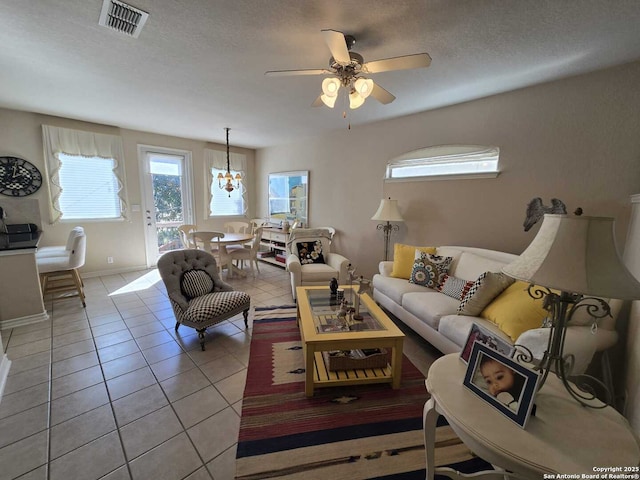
[256,63,640,276]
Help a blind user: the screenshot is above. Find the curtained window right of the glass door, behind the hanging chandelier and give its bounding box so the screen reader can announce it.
[204,149,247,217]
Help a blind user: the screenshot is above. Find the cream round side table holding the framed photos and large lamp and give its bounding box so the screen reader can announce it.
[424,354,640,480]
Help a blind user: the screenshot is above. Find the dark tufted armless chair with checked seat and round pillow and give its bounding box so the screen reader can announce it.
[158,249,251,350]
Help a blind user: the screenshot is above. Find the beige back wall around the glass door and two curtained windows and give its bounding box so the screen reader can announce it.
[0,109,255,274]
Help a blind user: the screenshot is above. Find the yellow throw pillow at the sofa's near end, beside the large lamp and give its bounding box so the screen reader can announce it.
[480,281,547,342]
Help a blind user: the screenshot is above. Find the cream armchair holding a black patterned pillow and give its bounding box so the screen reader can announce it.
[287,228,349,300]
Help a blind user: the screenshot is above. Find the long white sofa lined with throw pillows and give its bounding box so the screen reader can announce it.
[372,246,621,373]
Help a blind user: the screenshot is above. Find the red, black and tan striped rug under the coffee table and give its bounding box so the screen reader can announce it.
[236,306,490,480]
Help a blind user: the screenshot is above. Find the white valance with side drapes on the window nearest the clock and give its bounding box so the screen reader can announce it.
[42,125,128,224]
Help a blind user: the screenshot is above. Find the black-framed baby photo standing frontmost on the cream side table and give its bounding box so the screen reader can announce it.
[463,341,540,428]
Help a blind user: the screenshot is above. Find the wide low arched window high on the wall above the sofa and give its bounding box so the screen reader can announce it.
[385,145,500,181]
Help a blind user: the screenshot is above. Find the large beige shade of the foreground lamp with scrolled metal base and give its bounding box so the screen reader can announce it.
[502,214,640,300]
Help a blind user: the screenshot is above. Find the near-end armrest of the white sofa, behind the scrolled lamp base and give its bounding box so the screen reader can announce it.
[515,326,598,375]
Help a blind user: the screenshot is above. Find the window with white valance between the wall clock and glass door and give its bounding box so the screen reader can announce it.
[42,125,127,223]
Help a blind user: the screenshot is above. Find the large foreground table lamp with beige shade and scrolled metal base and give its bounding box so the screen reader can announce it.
[502,214,640,408]
